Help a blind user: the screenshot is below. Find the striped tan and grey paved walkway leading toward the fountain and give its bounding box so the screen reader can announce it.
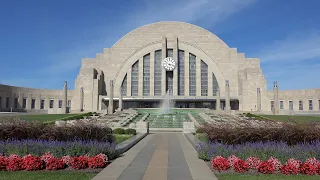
[93,133,217,180]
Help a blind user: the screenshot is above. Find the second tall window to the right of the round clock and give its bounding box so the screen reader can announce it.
[189,53,197,96]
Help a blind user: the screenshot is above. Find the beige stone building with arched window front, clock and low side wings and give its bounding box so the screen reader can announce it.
[0,22,320,114]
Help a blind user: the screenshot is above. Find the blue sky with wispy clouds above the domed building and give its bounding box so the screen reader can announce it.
[0,0,320,90]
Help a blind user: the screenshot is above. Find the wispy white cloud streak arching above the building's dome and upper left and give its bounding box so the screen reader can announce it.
[43,0,256,73]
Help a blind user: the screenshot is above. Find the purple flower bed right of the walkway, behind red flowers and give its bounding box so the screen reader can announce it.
[196,141,320,163]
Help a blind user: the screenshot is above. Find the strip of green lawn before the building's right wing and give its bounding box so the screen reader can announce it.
[261,115,320,123]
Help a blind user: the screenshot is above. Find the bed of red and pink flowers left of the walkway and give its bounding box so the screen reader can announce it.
[0,152,108,171]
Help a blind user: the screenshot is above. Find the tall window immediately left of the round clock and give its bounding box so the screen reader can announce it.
[154,50,162,96]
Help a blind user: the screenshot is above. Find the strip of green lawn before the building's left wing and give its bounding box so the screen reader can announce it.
[18,114,77,122]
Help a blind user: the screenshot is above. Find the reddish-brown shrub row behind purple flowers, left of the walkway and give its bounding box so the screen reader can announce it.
[0,120,115,142]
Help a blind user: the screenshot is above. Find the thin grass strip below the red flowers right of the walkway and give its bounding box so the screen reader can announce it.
[216,174,320,180]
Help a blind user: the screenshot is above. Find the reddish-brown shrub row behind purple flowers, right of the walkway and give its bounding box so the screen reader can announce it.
[198,123,320,145]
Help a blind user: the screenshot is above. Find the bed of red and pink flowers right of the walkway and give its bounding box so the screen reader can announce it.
[211,155,320,175]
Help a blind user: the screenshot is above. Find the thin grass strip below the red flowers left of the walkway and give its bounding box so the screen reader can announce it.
[0,171,97,180]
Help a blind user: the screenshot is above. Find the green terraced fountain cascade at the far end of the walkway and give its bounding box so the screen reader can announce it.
[138,109,199,128]
